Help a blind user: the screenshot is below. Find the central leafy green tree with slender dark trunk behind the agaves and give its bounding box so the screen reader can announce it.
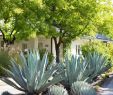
[39,0,111,62]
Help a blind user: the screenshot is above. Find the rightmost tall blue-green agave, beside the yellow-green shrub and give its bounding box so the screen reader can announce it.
[85,52,110,82]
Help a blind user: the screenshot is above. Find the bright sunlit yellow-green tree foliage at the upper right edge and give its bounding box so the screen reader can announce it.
[94,0,113,38]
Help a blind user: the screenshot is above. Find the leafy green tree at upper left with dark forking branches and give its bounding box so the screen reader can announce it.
[0,0,38,46]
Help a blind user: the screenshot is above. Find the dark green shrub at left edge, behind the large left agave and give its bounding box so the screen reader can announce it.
[0,51,10,76]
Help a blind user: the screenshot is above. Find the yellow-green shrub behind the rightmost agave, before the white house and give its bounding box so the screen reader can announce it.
[82,41,113,61]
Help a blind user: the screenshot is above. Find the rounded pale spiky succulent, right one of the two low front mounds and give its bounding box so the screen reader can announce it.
[71,81,97,95]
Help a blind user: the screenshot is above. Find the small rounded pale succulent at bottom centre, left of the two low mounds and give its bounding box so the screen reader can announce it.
[48,85,68,95]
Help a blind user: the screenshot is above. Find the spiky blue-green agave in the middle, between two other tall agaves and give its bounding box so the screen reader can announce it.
[63,56,89,87]
